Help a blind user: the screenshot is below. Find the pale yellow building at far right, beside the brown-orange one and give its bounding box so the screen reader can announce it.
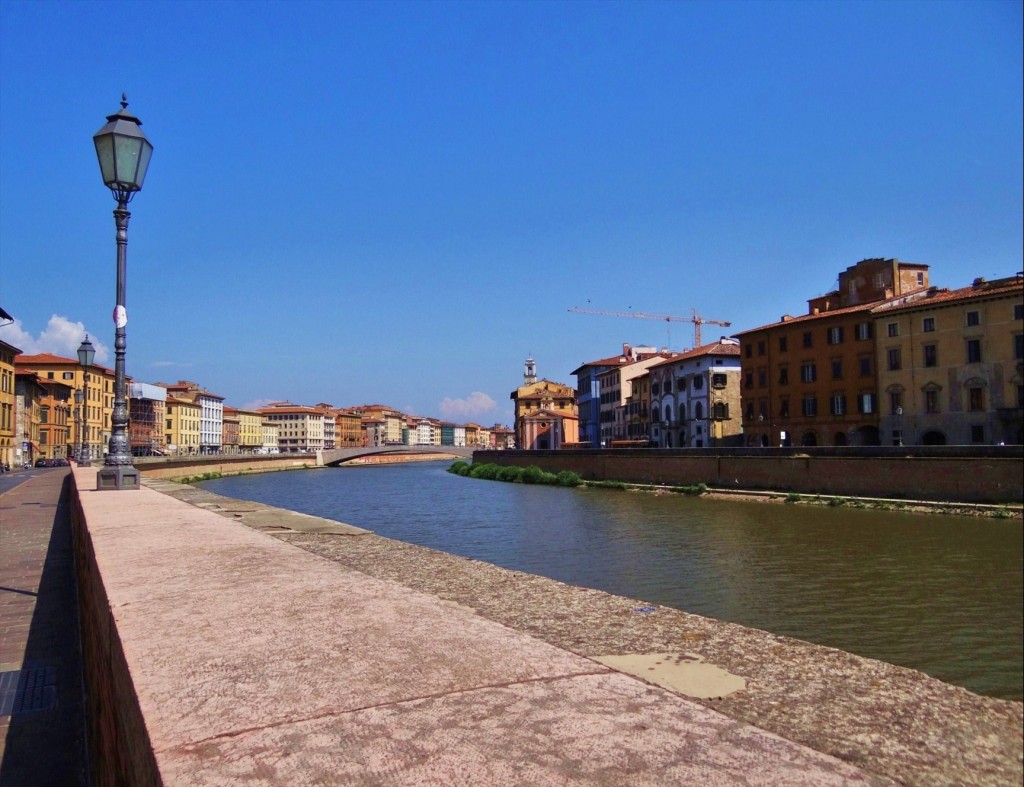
[872,275,1024,445]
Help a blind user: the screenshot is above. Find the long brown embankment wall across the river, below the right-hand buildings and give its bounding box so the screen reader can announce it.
[473,446,1024,504]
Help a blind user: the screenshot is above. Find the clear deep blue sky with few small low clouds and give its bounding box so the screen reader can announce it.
[0,0,1024,424]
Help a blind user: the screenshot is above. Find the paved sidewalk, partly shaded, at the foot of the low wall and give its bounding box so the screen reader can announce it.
[0,468,88,787]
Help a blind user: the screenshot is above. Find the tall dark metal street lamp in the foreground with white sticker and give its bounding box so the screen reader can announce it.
[92,93,153,489]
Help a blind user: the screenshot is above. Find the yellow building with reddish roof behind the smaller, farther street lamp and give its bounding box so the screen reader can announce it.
[14,353,115,458]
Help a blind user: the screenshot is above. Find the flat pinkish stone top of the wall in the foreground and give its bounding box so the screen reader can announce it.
[68,470,890,787]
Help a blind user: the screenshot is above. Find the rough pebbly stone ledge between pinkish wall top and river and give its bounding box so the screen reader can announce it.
[146,474,1024,785]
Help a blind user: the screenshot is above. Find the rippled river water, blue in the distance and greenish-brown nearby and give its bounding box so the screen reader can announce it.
[204,462,1024,700]
